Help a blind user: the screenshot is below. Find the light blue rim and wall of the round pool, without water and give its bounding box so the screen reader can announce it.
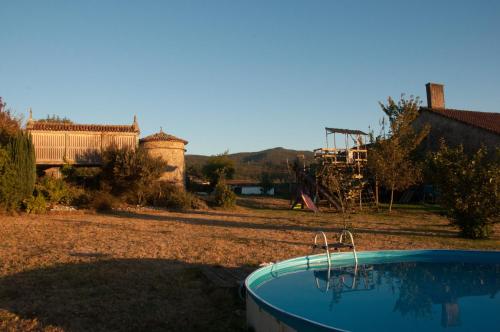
[245,250,500,332]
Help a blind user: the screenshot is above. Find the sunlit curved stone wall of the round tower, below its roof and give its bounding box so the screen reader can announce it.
[141,141,185,187]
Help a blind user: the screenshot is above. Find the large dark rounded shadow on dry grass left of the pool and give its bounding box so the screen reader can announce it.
[0,260,249,331]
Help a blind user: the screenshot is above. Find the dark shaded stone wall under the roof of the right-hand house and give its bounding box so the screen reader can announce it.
[414,110,500,153]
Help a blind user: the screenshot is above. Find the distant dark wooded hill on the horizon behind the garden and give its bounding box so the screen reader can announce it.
[186,147,314,180]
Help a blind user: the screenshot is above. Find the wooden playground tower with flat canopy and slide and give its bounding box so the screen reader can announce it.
[292,127,375,212]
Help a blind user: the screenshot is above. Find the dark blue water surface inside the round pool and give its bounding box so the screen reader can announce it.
[248,252,500,332]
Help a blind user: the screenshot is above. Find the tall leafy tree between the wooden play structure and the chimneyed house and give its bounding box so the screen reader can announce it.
[368,95,430,211]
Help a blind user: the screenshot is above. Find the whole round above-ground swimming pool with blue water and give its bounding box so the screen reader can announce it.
[245,250,500,332]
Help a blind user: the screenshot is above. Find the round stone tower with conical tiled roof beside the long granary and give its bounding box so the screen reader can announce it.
[139,129,188,187]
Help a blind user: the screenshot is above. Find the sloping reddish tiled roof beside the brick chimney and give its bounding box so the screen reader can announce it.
[421,107,500,135]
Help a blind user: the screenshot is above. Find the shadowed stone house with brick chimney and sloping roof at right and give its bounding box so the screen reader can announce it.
[414,83,500,153]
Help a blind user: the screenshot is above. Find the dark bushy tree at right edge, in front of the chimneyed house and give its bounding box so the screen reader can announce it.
[427,142,500,239]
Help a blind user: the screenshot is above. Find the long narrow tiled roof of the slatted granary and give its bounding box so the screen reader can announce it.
[26,121,139,133]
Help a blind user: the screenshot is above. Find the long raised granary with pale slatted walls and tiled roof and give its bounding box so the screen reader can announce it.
[26,110,140,168]
